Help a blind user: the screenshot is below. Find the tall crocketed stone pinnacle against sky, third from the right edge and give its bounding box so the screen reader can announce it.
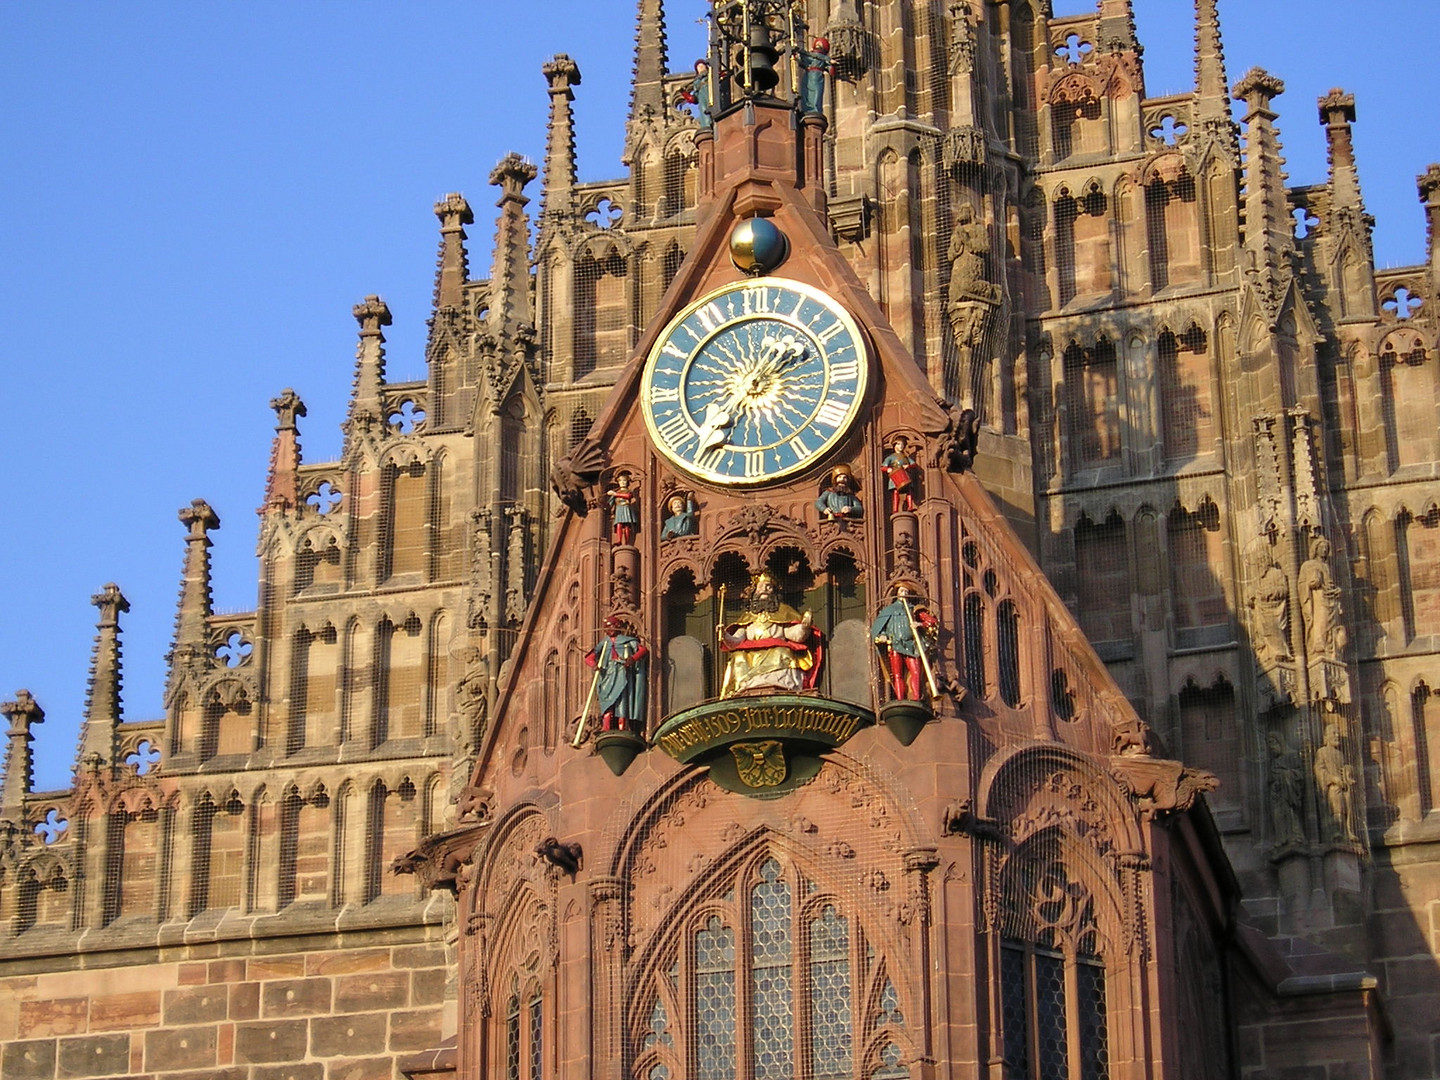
[1233,68,1295,315]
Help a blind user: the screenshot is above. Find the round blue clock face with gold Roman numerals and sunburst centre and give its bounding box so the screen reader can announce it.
[642,278,868,484]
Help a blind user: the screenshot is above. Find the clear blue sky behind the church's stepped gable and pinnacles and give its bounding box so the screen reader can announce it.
[0,0,1440,789]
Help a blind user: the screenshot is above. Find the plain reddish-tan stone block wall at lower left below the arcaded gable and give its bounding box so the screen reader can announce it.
[0,926,454,1080]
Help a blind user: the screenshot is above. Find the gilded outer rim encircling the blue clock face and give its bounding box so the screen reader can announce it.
[641,275,870,488]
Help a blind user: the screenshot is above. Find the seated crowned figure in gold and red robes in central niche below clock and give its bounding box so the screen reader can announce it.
[716,573,822,697]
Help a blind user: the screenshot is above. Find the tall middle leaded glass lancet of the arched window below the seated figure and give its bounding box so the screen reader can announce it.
[750,858,795,1080]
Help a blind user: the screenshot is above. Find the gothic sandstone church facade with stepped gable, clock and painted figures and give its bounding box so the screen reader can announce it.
[0,0,1440,1080]
